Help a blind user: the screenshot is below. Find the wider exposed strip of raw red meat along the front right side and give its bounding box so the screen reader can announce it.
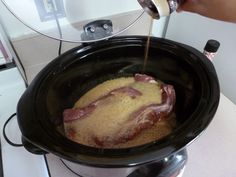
[93,84,175,148]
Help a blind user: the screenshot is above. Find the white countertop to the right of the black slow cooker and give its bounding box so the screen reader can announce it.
[183,94,236,177]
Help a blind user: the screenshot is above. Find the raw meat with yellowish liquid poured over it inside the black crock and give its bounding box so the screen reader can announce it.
[63,74,176,148]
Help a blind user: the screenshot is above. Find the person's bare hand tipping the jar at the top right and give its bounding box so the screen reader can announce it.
[177,0,236,23]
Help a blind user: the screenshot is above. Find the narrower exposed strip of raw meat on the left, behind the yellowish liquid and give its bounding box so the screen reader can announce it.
[63,87,142,122]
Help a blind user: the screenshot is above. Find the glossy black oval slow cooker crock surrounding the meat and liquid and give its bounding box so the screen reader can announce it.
[17,36,220,167]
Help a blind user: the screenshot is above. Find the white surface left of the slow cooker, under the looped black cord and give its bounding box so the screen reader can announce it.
[0,68,48,177]
